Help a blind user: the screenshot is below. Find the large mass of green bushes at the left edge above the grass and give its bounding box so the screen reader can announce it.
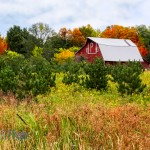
[0,55,55,98]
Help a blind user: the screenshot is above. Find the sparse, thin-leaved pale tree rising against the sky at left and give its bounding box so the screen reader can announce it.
[29,22,56,42]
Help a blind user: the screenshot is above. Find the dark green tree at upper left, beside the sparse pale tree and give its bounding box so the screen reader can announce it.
[7,25,42,57]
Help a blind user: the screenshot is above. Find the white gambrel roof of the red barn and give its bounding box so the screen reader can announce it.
[88,37,143,62]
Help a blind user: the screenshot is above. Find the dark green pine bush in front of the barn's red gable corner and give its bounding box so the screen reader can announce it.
[85,58,108,90]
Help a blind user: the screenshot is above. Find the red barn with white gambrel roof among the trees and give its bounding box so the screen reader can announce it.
[75,37,150,68]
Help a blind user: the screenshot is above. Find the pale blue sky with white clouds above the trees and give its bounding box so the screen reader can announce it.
[0,0,150,36]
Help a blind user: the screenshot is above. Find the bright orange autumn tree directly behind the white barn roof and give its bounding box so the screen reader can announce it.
[101,25,148,56]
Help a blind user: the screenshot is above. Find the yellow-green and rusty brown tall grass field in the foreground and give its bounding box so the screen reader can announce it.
[0,72,150,150]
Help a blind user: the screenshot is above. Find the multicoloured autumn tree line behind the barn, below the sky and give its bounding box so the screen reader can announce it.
[0,23,150,62]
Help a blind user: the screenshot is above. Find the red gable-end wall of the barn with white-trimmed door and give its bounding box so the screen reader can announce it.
[75,40,102,62]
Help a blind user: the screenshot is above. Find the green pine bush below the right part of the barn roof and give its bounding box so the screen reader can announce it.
[111,62,145,95]
